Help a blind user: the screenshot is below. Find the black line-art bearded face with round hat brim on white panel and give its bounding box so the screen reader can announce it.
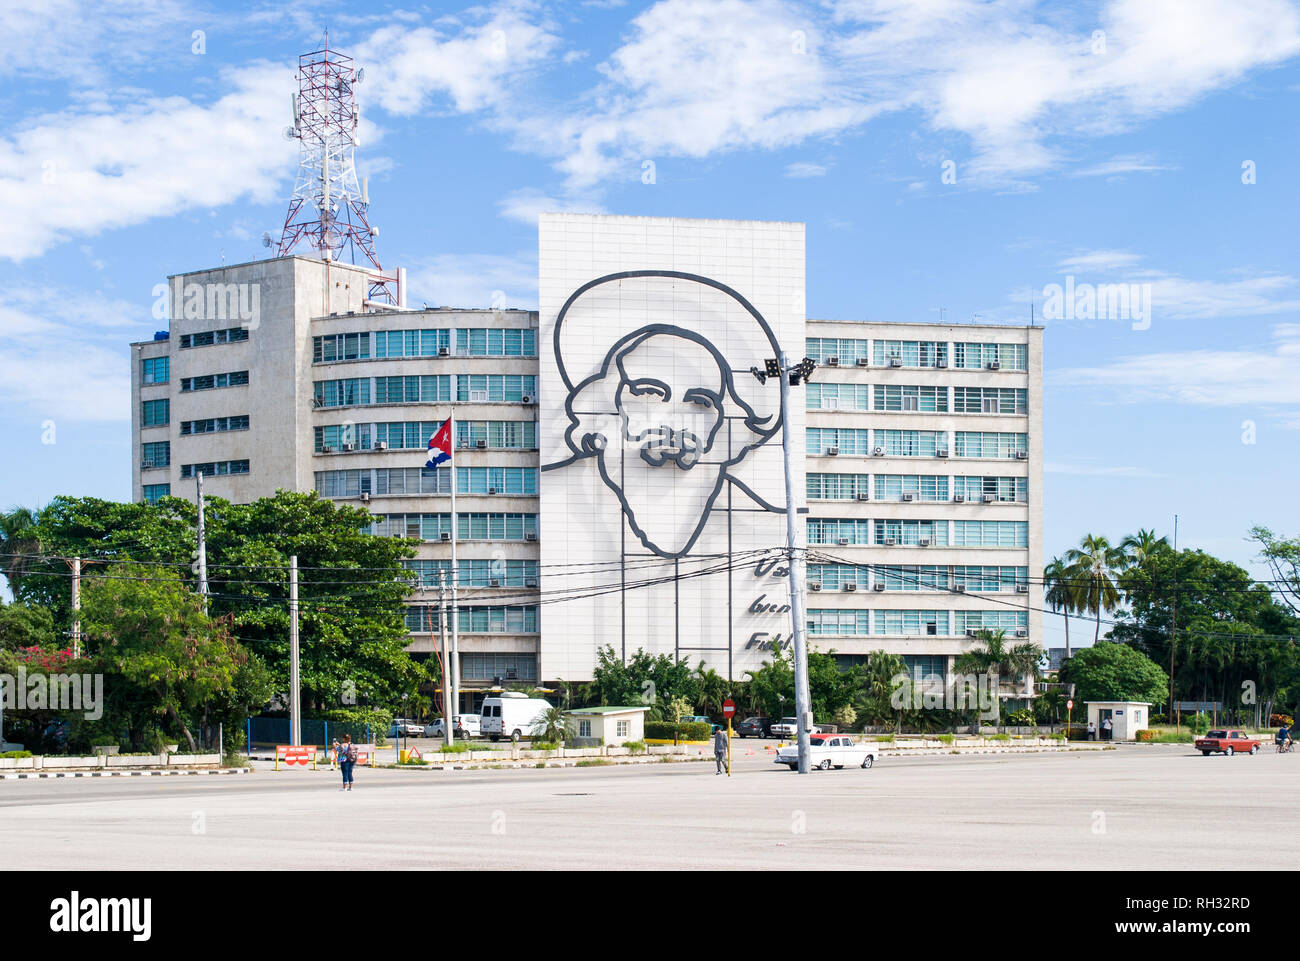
[542,270,781,558]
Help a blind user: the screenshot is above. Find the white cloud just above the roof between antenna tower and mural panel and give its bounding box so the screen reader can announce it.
[407,251,537,309]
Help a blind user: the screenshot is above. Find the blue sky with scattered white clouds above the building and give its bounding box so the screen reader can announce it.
[0,0,1300,644]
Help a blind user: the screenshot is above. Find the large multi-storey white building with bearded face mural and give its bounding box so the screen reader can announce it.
[131,215,1043,704]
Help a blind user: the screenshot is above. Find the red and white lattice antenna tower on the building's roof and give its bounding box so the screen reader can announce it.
[276,29,398,304]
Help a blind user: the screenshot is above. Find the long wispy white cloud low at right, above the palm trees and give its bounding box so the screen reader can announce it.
[1048,324,1300,408]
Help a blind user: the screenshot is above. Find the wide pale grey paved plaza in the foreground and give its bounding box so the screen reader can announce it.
[0,740,1300,870]
